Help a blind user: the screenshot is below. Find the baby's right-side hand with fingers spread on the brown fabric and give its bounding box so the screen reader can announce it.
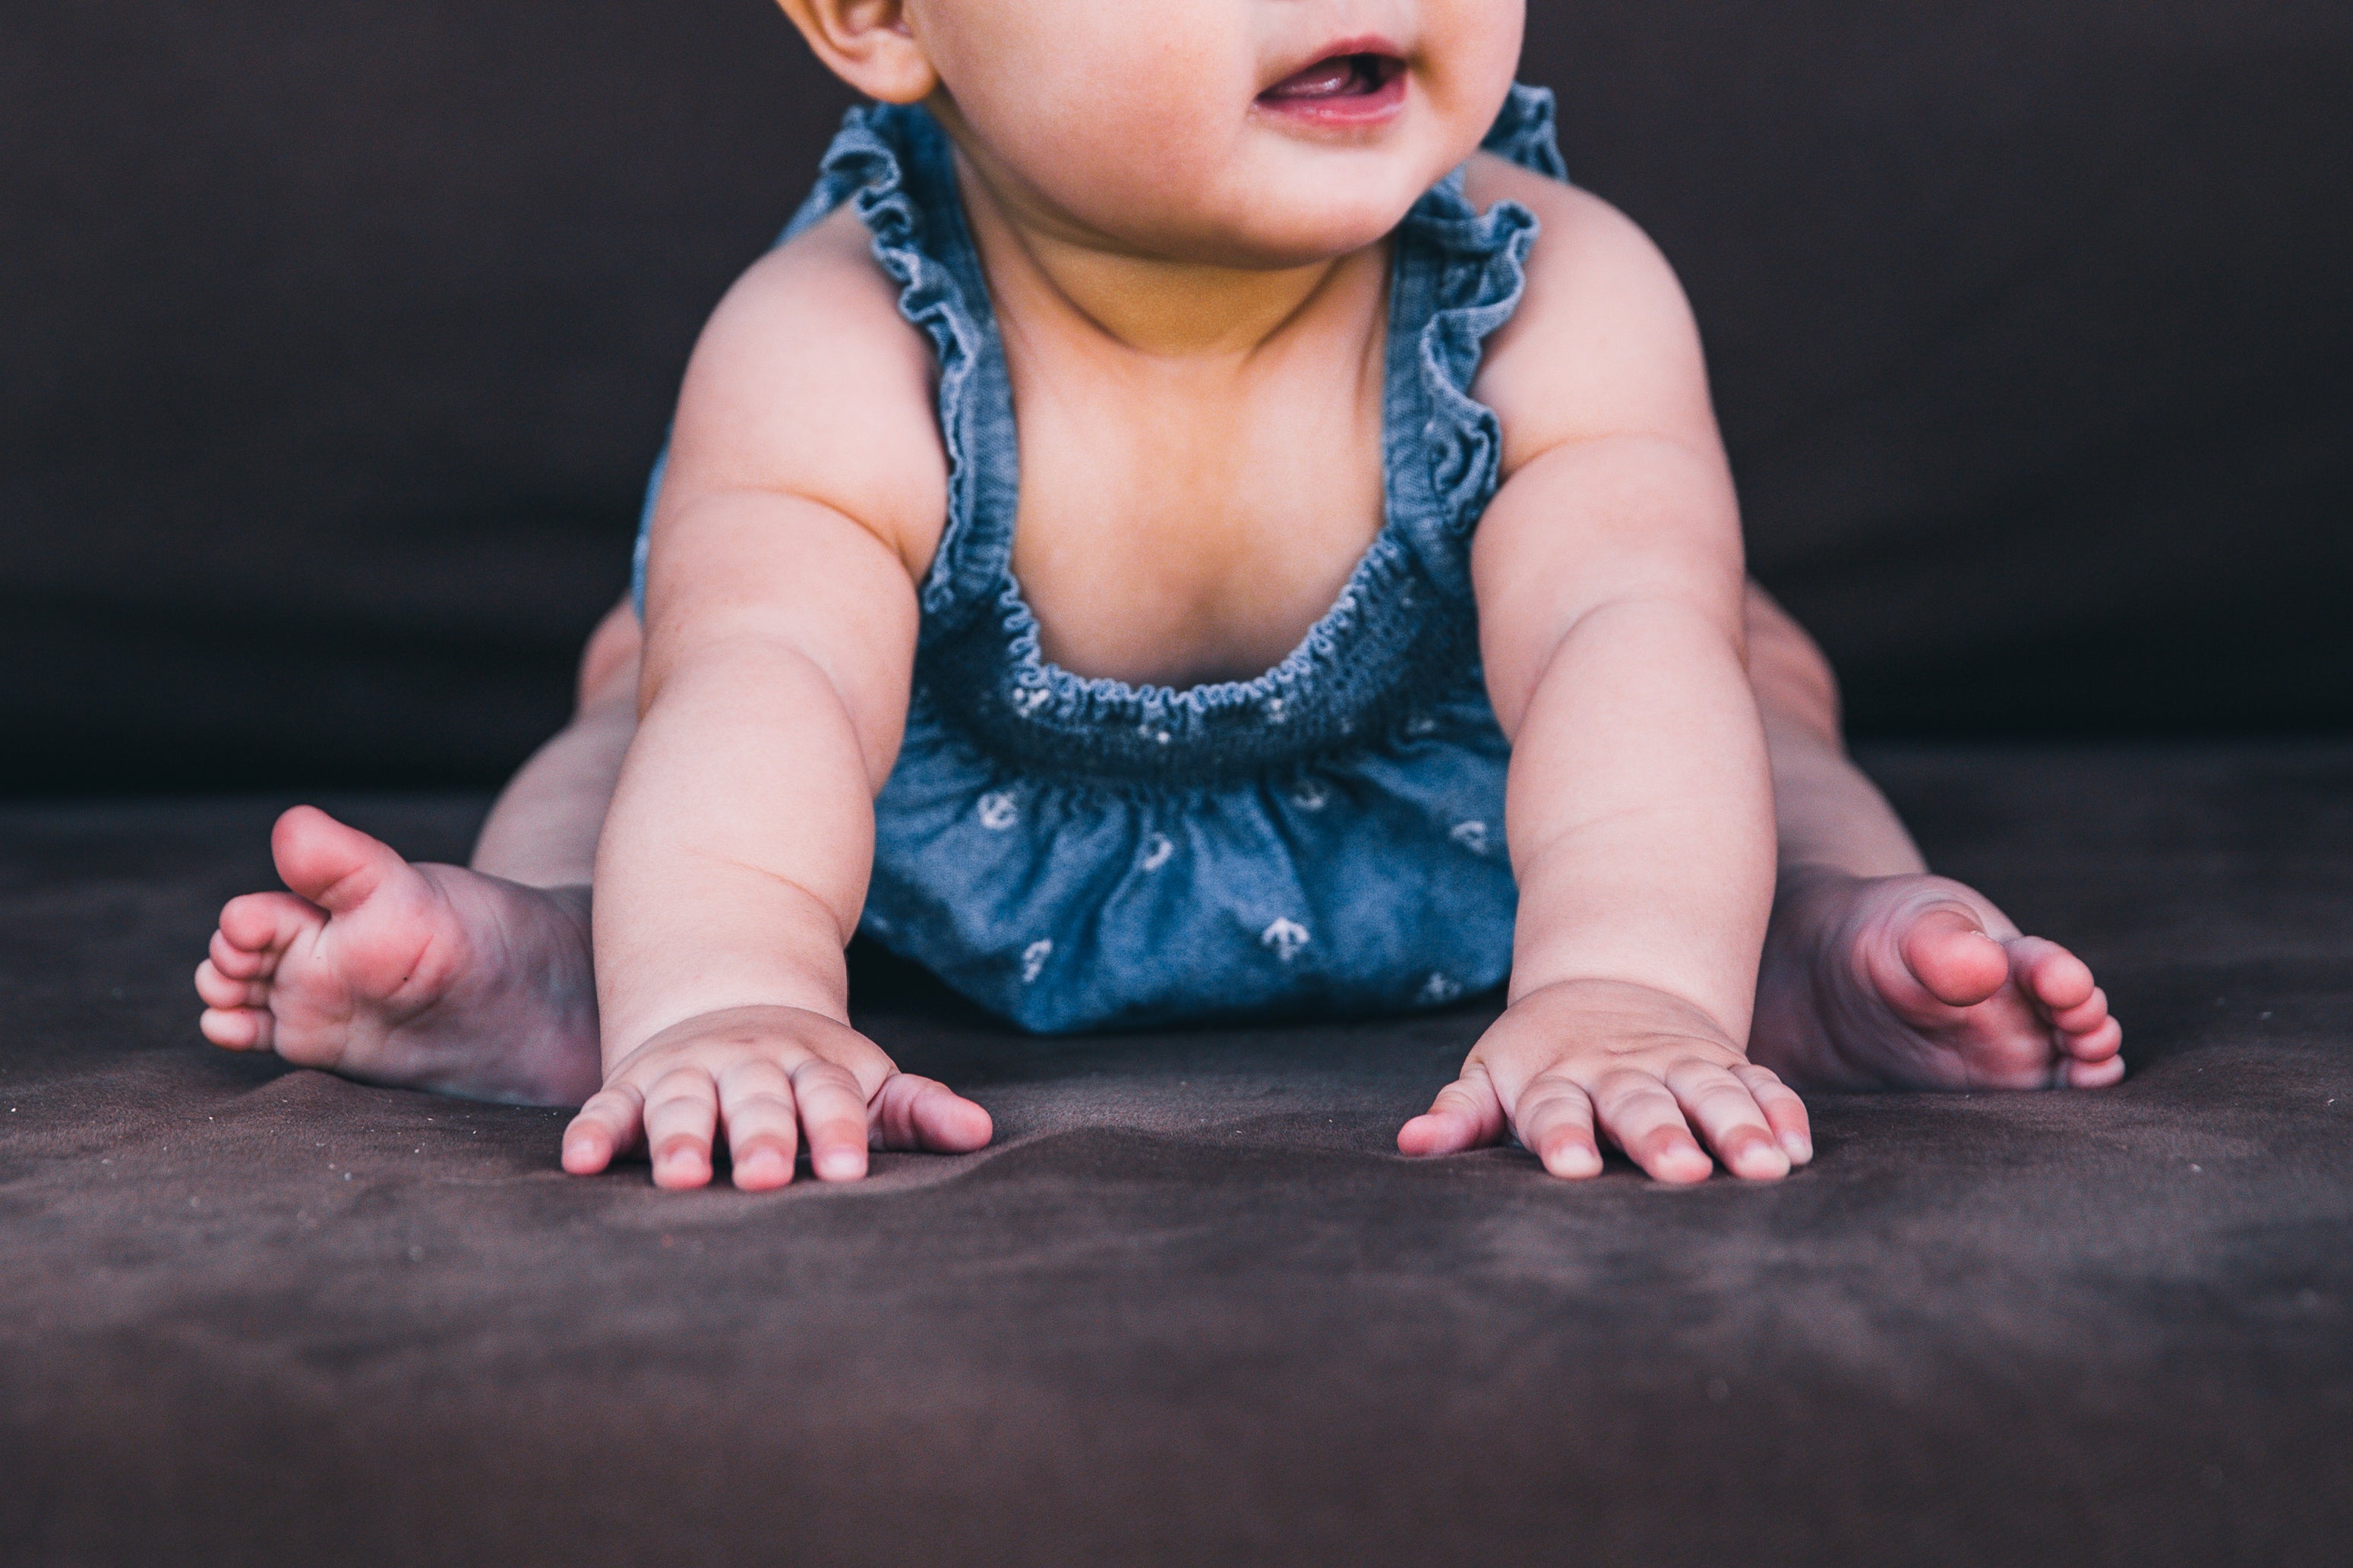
[1398,980,1814,1182]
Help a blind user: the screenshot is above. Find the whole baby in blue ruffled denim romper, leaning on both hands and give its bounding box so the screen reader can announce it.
[195,0,2122,1187]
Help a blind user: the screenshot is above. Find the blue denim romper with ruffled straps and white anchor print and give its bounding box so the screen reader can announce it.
[635,87,1565,1032]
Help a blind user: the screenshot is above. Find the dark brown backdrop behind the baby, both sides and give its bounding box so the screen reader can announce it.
[0,0,2353,794]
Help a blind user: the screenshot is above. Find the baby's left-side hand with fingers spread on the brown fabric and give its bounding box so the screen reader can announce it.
[565,1006,990,1192]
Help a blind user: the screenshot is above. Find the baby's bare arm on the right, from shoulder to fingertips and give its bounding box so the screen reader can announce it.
[1400,157,1807,1180]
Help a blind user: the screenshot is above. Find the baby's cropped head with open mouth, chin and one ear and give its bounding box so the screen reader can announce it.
[782,0,1525,266]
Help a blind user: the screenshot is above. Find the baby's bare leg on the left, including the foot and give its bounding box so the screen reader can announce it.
[195,604,638,1105]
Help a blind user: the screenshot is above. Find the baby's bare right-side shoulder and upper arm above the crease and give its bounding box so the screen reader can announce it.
[1464,153,1713,472]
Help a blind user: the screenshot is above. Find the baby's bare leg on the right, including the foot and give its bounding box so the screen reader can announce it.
[1748,588,2124,1088]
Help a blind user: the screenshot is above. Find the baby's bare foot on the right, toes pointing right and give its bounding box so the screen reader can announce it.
[1748,870,2124,1088]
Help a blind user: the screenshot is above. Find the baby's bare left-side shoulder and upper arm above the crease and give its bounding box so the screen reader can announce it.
[666,210,948,545]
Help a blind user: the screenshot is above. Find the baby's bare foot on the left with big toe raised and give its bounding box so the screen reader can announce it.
[195,806,602,1105]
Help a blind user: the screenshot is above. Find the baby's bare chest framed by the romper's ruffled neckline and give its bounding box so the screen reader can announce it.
[1014,374,1384,689]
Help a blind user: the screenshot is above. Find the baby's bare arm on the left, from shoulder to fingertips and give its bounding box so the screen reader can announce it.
[565,214,988,1187]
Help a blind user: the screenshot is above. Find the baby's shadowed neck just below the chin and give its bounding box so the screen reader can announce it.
[958,126,1386,362]
